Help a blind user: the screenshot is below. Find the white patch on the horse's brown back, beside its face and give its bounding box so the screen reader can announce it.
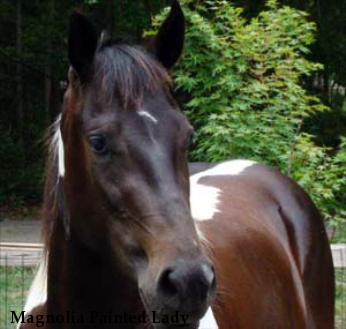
[190,160,256,221]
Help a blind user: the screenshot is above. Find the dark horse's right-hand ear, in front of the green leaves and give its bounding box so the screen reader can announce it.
[154,0,185,69]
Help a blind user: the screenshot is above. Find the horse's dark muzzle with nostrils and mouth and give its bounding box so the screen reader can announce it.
[144,256,216,322]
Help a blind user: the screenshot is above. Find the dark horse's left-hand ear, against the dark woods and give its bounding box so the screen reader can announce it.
[68,10,97,79]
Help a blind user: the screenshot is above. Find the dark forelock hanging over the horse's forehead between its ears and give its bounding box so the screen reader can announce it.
[93,45,171,108]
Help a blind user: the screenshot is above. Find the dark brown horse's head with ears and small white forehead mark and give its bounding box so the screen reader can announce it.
[60,1,215,323]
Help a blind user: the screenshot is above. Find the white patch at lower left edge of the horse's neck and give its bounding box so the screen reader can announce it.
[18,256,47,325]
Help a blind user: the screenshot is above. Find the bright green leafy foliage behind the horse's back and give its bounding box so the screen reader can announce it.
[154,0,346,236]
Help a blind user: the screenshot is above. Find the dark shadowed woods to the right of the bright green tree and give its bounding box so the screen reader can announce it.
[229,0,346,149]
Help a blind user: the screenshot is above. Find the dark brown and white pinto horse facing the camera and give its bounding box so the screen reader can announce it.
[19,0,334,329]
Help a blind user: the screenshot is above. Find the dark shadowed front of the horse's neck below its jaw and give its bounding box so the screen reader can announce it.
[47,215,143,326]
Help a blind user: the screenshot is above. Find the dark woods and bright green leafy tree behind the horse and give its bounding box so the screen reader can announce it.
[0,0,346,240]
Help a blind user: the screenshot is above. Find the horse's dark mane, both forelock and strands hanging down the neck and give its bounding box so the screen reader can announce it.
[42,41,171,252]
